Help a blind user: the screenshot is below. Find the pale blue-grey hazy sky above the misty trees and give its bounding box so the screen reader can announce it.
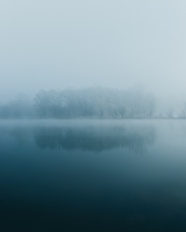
[0,0,186,100]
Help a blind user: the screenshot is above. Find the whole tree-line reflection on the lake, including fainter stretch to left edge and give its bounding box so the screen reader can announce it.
[0,121,156,154]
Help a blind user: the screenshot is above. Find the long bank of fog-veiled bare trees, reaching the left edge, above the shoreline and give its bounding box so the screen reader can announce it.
[0,88,156,119]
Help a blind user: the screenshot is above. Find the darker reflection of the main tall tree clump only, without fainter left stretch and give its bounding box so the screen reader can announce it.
[34,126,155,153]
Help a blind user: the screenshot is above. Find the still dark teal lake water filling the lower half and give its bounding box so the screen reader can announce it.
[0,120,186,232]
